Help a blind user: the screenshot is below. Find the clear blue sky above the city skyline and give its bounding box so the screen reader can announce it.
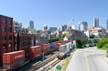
[0,0,108,29]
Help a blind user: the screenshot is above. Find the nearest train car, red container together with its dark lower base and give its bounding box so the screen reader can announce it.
[3,50,25,70]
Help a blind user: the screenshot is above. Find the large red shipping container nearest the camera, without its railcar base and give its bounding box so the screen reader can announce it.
[3,50,25,64]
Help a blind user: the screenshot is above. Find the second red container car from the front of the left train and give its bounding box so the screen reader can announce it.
[30,46,42,60]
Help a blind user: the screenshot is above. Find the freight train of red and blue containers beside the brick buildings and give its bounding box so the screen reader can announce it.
[3,42,69,70]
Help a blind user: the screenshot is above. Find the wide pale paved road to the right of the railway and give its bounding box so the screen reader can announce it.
[66,47,108,71]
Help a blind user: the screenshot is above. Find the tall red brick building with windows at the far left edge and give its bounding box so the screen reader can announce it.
[0,15,14,66]
